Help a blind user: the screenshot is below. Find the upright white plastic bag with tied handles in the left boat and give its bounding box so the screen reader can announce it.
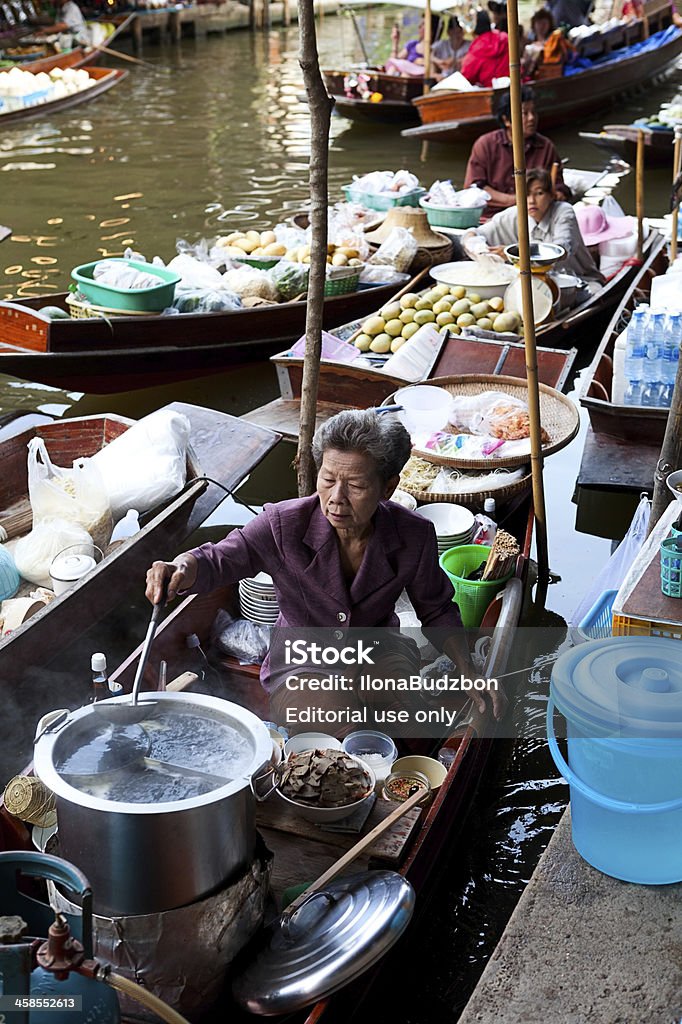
[29,437,114,548]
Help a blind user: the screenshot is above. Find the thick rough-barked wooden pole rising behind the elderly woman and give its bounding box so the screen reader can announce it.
[296,0,334,497]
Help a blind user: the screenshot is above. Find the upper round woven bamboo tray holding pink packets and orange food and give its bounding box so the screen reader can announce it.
[391,374,580,469]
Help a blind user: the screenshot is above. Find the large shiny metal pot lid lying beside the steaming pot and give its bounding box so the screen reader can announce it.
[232,871,415,1017]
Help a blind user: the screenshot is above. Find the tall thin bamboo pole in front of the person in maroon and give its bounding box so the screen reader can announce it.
[507,0,549,604]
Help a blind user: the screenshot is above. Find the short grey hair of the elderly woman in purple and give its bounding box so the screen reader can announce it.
[312,409,412,483]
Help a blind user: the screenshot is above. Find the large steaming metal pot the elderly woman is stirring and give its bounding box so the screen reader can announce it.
[34,692,272,916]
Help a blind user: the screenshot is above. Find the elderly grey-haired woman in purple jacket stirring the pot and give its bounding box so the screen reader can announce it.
[146,410,505,722]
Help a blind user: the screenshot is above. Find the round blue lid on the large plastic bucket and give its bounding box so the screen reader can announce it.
[550,637,682,739]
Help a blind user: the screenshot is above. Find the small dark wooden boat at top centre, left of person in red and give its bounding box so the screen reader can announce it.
[322,68,424,125]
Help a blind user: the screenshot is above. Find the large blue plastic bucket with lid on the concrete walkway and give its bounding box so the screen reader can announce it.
[547,637,682,885]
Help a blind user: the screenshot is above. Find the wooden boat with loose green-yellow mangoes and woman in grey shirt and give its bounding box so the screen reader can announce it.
[242,233,663,440]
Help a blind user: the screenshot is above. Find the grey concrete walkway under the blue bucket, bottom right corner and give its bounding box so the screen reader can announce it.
[459,811,682,1024]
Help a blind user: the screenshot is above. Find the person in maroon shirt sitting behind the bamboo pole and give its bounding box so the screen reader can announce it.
[464,86,568,216]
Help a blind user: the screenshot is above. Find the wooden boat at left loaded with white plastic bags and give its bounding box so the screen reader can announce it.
[0,402,279,763]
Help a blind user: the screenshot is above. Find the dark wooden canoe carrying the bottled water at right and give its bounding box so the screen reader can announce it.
[580,234,668,447]
